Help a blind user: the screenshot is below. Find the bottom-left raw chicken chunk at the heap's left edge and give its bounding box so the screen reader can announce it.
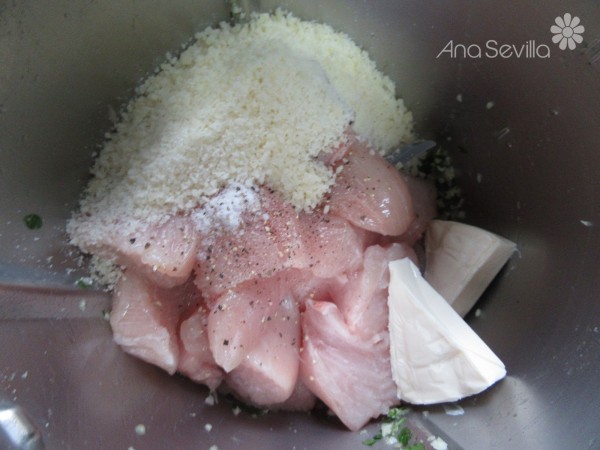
[110,270,198,374]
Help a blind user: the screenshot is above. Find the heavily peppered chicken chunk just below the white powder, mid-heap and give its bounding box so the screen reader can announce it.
[195,189,308,298]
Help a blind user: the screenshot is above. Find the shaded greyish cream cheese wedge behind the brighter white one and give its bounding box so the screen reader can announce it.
[425,220,516,317]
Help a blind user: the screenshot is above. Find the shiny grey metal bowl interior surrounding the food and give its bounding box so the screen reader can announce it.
[0,0,600,450]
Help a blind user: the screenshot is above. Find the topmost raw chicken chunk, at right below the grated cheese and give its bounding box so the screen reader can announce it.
[329,141,415,236]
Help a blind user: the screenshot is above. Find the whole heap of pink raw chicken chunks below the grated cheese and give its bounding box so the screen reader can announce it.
[101,132,436,430]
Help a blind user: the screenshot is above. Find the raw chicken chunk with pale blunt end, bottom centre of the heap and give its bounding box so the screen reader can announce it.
[226,296,301,406]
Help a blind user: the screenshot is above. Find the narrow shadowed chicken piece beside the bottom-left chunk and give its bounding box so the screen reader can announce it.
[177,302,223,389]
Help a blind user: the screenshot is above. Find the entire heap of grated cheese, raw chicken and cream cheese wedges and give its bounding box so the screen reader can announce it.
[67,11,514,430]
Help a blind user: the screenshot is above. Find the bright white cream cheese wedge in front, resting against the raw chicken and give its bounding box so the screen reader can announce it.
[388,258,506,405]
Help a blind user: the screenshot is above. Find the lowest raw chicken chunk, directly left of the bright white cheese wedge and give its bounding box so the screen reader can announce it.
[300,300,398,430]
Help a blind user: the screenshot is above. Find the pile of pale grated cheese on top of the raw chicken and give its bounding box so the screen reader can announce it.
[67,10,412,253]
